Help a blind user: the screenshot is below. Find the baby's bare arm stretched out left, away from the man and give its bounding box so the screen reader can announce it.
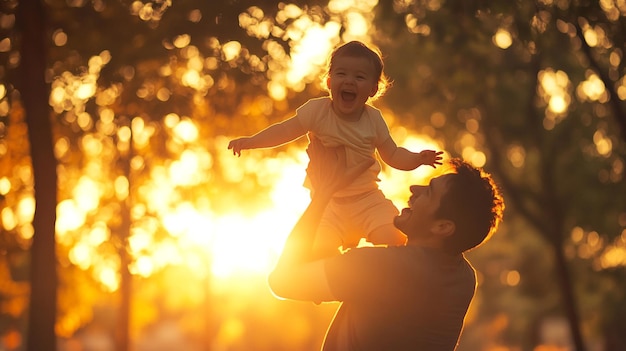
[228,117,306,156]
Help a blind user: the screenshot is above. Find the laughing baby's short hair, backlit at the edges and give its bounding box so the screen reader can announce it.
[322,40,391,101]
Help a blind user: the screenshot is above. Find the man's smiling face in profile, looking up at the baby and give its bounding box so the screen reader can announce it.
[394,174,451,239]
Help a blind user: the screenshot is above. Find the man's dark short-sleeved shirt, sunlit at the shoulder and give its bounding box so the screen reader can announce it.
[322,246,476,351]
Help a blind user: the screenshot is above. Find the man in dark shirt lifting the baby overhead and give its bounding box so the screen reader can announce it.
[269,142,504,351]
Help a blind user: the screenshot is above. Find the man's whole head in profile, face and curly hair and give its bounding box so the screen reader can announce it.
[394,159,504,254]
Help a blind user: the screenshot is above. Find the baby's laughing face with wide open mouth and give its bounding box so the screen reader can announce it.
[326,56,378,120]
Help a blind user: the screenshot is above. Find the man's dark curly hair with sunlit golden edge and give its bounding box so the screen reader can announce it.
[435,158,504,254]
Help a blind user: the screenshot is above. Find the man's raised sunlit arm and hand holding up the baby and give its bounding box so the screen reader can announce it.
[269,139,372,302]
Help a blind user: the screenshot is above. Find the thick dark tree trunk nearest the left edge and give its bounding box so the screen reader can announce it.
[16,0,57,351]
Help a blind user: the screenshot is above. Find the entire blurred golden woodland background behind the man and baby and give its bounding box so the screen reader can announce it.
[0,0,626,351]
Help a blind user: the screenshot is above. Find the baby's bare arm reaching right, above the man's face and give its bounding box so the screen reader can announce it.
[378,138,443,171]
